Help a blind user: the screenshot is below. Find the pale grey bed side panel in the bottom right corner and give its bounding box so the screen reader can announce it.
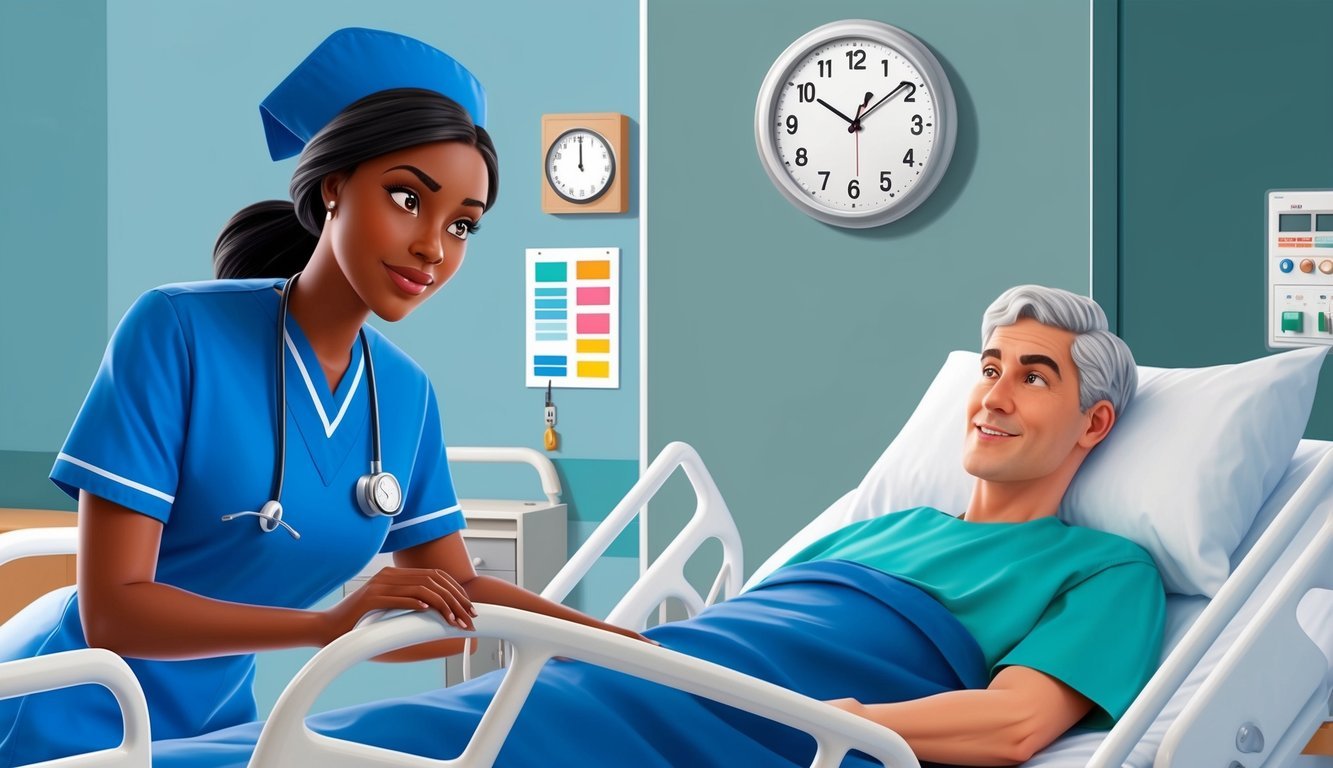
[1154,504,1333,768]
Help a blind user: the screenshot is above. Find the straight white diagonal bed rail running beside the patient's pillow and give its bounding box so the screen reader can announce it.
[1088,449,1333,768]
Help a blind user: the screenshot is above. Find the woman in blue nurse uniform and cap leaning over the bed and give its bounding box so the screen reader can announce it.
[0,29,637,765]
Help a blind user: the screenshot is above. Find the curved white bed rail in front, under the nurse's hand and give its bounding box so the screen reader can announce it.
[251,604,920,768]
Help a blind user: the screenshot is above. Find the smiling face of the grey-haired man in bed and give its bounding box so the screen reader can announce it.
[962,317,1089,483]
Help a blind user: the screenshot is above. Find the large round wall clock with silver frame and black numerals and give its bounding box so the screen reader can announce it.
[754,20,957,228]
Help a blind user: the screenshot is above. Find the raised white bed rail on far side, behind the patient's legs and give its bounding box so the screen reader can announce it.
[541,443,744,631]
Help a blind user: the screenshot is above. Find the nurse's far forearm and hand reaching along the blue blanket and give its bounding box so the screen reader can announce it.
[379,532,651,661]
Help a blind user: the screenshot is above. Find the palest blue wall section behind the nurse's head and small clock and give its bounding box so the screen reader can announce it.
[107,0,639,460]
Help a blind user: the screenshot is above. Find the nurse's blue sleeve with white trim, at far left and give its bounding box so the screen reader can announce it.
[51,291,191,523]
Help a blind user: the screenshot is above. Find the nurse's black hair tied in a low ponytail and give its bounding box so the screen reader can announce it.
[213,88,500,279]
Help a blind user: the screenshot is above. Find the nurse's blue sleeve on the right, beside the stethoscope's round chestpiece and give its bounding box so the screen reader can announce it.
[380,385,465,552]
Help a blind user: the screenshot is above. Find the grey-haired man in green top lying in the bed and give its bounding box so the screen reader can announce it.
[793,285,1165,765]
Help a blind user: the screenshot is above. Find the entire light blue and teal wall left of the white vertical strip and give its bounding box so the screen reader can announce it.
[0,0,640,605]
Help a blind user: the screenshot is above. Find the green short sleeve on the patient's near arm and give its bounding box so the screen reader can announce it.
[994,561,1166,728]
